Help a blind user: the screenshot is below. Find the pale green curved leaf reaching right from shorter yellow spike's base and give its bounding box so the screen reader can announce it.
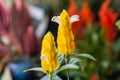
[55,64,79,74]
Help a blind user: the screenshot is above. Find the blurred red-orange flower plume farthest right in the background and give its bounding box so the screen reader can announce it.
[99,0,118,41]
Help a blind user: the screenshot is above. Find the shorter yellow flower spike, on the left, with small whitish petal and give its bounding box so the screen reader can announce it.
[41,32,58,72]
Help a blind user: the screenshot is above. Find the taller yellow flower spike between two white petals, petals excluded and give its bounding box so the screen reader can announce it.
[57,10,75,55]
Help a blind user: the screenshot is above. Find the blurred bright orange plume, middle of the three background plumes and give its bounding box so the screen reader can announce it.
[79,0,94,26]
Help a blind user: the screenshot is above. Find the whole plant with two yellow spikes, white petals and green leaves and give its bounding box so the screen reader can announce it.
[25,10,95,80]
